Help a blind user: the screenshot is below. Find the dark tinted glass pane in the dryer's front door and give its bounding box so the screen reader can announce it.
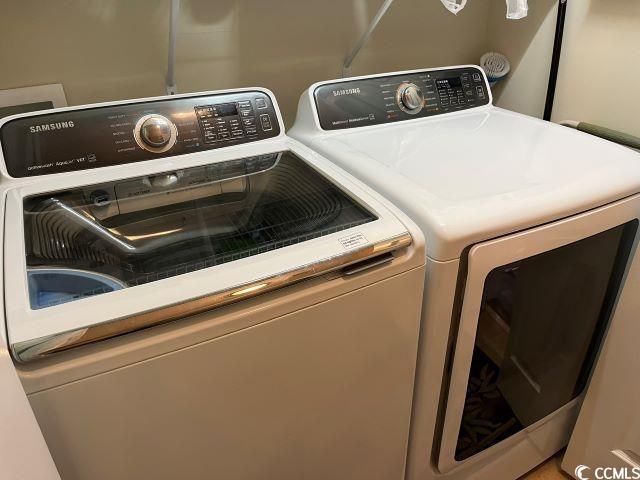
[455,221,637,461]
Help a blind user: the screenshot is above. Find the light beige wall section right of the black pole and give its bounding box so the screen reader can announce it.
[552,0,640,136]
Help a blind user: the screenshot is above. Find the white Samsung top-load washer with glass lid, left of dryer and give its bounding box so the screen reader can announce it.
[0,88,425,480]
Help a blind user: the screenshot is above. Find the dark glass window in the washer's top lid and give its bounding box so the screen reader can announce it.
[24,152,376,309]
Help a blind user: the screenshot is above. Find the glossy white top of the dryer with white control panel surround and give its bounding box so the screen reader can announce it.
[289,67,640,260]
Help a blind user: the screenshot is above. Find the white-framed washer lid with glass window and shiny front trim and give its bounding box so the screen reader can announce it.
[4,144,416,360]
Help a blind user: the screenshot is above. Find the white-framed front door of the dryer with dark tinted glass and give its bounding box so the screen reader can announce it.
[438,197,640,472]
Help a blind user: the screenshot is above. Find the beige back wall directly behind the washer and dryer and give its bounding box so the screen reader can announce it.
[0,0,490,124]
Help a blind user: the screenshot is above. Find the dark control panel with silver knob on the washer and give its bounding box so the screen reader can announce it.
[0,90,280,177]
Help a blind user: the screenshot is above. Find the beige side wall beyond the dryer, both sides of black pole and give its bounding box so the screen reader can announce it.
[488,0,640,136]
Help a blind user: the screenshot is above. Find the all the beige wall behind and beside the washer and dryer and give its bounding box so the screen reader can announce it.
[0,0,640,135]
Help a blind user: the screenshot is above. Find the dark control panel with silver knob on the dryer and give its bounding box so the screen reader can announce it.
[314,67,490,130]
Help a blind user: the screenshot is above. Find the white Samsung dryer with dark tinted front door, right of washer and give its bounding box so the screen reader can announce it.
[289,66,640,480]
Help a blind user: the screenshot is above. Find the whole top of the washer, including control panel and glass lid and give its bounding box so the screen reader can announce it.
[0,89,424,361]
